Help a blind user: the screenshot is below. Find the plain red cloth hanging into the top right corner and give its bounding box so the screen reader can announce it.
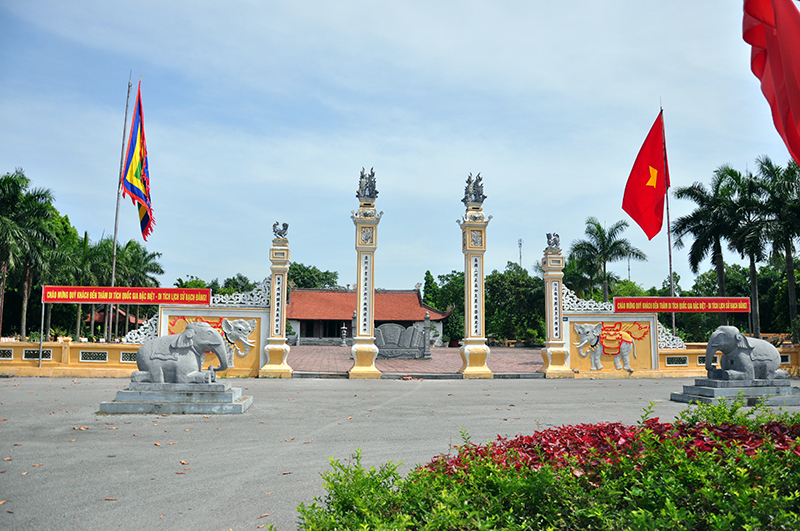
[742,0,800,163]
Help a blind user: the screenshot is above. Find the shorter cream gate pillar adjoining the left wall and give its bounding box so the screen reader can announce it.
[258,221,292,378]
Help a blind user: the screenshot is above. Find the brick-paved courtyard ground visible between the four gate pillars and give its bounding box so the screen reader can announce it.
[286,345,542,374]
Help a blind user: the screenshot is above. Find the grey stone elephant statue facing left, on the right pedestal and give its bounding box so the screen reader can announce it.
[706,326,789,380]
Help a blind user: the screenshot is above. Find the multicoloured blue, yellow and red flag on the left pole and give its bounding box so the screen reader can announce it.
[122,81,155,241]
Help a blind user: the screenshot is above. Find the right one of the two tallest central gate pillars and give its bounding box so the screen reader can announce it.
[456,173,494,378]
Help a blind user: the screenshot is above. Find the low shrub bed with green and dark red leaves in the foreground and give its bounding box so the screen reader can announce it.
[298,400,800,531]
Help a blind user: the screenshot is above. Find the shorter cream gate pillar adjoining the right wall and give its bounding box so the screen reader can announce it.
[540,234,574,378]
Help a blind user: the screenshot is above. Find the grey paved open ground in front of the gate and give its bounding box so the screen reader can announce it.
[0,378,800,531]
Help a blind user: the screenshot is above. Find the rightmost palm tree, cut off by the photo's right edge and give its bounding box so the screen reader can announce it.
[756,155,800,339]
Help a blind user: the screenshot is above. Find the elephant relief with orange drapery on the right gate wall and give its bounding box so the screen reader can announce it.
[574,323,647,372]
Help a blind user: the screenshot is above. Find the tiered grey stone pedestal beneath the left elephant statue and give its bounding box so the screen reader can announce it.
[100,382,253,415]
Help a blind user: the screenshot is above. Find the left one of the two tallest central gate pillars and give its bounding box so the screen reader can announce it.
[350,168,383,378]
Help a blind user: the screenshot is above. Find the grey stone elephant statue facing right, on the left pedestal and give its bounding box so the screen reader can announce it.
[131,321,228,383]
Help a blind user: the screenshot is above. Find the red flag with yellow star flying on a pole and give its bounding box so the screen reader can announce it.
[622,110,669,240]
